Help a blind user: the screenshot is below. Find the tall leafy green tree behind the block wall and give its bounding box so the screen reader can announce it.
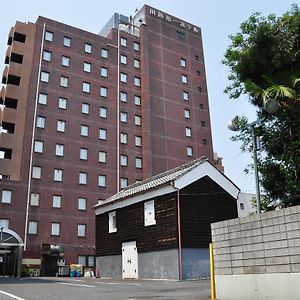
[223,5,300,210]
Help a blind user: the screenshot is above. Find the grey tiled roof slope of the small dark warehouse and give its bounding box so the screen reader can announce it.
[95,156,207,207]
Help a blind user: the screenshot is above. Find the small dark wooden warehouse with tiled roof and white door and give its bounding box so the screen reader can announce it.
[95,158,239,279]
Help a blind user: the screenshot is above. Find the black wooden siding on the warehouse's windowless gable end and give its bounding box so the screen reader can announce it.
[180,177,237,248]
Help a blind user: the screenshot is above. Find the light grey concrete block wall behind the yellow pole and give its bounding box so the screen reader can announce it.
[211,206,300,300]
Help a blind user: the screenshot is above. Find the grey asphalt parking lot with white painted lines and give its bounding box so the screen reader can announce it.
[0,277,210,300]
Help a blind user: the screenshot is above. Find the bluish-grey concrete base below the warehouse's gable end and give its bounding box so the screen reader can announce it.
[182,248,209,279]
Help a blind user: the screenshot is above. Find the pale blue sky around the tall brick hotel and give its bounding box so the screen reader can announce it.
[0,0,300,192]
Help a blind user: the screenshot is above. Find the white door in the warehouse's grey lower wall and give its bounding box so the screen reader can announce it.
[122,241,138,279]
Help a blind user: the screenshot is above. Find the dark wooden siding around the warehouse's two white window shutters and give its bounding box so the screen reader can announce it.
[96,194,178,256]
